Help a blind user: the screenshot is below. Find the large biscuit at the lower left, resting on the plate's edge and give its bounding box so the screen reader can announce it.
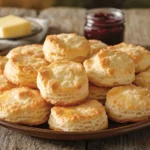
[0,87,51,126]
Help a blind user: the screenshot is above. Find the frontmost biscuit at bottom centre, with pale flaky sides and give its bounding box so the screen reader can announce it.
[48,100,108,132]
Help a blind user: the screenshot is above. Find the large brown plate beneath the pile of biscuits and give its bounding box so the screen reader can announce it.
[0,119,150,140]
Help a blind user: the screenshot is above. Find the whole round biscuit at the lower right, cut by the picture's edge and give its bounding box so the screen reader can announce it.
[105,85,150,123]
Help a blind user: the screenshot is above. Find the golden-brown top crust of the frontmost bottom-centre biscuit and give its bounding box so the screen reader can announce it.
[51,100,105,122]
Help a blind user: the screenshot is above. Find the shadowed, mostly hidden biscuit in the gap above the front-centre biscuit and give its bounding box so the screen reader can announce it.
[87,84,111,104]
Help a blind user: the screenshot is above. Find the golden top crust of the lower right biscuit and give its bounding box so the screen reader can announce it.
[106,85,150,111]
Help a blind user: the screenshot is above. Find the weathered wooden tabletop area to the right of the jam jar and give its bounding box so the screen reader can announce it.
[125,9,150,47]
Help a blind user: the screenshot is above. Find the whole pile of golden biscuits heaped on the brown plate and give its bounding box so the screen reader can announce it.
[0,33,150,132]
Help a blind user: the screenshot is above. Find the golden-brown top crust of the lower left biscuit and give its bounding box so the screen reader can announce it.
[0,87,49,113]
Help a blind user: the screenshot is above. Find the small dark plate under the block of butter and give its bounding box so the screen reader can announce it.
[0,19,42,40]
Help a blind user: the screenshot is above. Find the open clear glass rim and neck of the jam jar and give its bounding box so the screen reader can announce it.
[86,8,124,26]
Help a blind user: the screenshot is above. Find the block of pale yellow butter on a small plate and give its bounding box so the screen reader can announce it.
[0,15,31,38]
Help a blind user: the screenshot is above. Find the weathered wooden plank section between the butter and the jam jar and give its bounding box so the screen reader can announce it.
[39,7,87,35]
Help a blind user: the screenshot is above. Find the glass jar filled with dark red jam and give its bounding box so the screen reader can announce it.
[84,8,125,45]
